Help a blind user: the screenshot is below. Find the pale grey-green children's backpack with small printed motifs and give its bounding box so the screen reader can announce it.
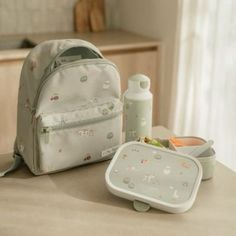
[15,39,122,174]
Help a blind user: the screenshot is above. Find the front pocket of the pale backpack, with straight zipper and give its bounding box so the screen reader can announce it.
[34,98,122,174]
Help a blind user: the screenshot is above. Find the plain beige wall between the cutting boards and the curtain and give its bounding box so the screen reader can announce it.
[107,0,178,127]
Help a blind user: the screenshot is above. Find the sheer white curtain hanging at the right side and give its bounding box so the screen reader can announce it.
[170,0,236,170]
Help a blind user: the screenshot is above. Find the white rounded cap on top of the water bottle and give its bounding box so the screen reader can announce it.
[128,74,150,93]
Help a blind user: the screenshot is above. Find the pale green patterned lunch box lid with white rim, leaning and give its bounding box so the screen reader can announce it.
[105,142,202,213]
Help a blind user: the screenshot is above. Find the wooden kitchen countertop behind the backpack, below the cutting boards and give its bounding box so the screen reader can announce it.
[0,30,160,61]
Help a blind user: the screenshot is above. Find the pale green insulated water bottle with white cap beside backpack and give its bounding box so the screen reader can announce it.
[124,74,152,142]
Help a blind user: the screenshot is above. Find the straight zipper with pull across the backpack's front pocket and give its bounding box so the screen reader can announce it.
[41,111,122,144]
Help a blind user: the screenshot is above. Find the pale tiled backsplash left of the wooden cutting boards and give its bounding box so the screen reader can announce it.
[0,0,77,35]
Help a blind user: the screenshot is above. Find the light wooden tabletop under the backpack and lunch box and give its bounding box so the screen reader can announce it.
[0,127,236,236]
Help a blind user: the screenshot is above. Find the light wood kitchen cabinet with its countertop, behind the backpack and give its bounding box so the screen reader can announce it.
[0,30,161,153]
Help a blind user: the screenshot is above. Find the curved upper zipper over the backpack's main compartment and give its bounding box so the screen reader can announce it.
[31,58,117,115]
